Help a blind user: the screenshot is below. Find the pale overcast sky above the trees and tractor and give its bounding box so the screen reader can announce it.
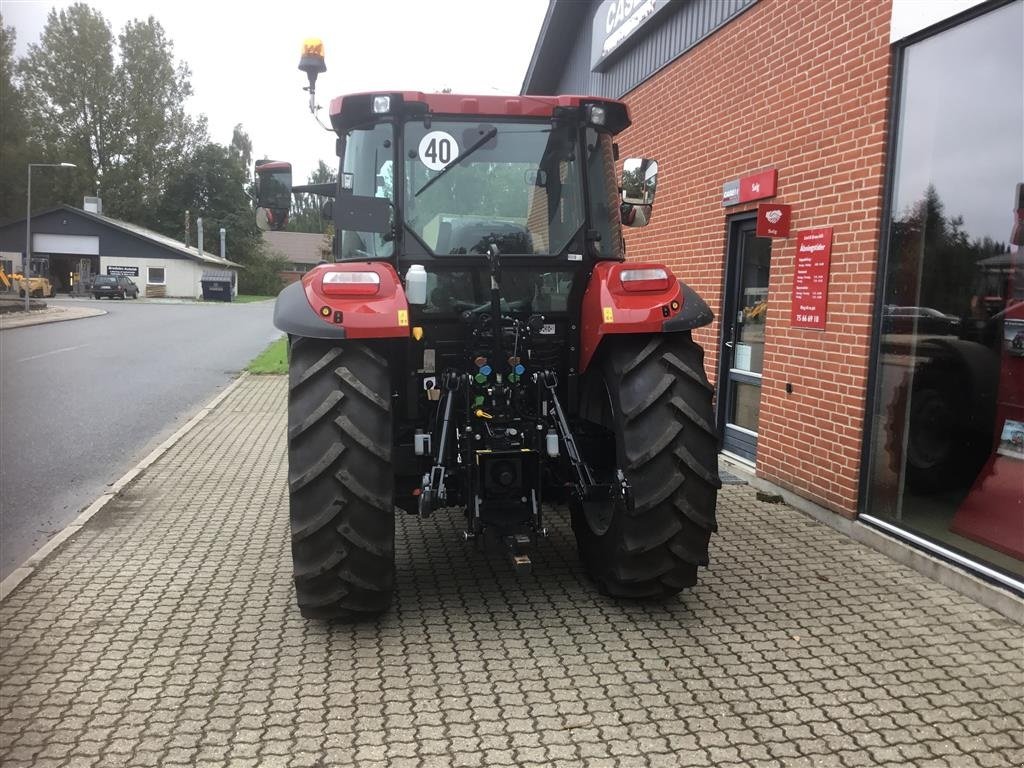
[0,0,548,181]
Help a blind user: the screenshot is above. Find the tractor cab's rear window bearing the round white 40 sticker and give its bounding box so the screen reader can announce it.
[404,121,584,255]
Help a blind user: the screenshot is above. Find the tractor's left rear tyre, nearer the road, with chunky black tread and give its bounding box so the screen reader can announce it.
[288,338,394,621]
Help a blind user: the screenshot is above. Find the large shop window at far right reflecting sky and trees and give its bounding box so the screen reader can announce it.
[866,0,1024,578]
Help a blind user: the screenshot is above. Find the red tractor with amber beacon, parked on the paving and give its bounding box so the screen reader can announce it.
[256,40,721,618]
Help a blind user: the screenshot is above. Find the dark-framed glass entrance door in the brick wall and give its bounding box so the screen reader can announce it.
[719,219,771,462]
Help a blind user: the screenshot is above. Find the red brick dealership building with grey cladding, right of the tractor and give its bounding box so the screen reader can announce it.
[523,0,1024,589]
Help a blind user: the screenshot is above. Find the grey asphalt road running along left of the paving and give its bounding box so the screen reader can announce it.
[0,299,280,579]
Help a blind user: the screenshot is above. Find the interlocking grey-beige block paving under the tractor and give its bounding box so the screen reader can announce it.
[0,377,1024,768]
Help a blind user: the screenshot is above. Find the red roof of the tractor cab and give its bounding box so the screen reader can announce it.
[331,91,630,133]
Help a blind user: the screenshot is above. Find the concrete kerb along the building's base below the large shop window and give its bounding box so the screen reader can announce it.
[720,456,1024,625]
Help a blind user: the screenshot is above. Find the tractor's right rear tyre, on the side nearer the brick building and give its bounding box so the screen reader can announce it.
[570,332,722,598]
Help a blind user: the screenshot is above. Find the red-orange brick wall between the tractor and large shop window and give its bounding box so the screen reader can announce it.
[618,0,891,516]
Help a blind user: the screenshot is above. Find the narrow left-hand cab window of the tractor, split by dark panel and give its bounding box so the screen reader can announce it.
[338,123,394,259]
